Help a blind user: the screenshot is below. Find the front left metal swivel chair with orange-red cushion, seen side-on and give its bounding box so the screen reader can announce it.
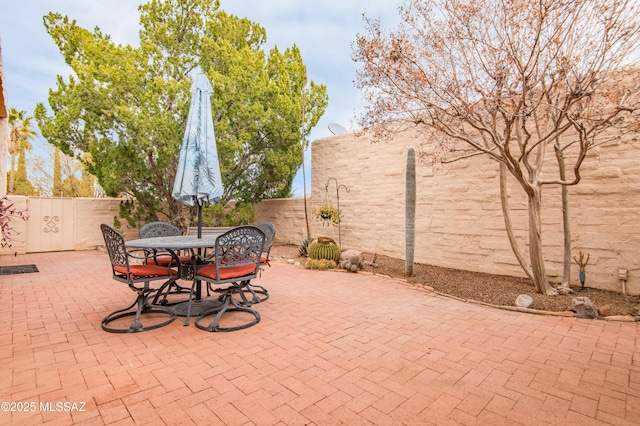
[100,224,180,333]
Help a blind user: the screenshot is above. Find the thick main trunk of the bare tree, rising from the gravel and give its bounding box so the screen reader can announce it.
[527,186,557,295]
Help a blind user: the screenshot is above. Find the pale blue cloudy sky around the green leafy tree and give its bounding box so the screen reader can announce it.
[0,0,401,196]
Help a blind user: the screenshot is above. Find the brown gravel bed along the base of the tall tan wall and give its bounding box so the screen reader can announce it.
[271,245,640,316]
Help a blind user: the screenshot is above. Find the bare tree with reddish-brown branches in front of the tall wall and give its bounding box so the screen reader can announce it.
[354,0,640,294]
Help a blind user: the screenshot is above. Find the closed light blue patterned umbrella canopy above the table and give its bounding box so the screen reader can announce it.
[172,73,223,207]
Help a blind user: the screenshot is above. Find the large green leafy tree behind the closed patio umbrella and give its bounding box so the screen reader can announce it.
[36,0,327,226]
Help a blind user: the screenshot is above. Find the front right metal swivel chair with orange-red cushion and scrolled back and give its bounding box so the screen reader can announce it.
[185,226,265,331]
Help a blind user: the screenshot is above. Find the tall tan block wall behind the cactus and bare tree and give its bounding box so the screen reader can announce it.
[312,132,640,294]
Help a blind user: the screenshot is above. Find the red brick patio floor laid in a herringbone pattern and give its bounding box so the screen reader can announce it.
[0,251,640,426]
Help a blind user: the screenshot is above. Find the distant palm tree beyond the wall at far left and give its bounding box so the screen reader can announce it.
[7,107,36,195]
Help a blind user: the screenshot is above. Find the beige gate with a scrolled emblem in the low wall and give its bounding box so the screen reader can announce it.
[27,197,75,253]
